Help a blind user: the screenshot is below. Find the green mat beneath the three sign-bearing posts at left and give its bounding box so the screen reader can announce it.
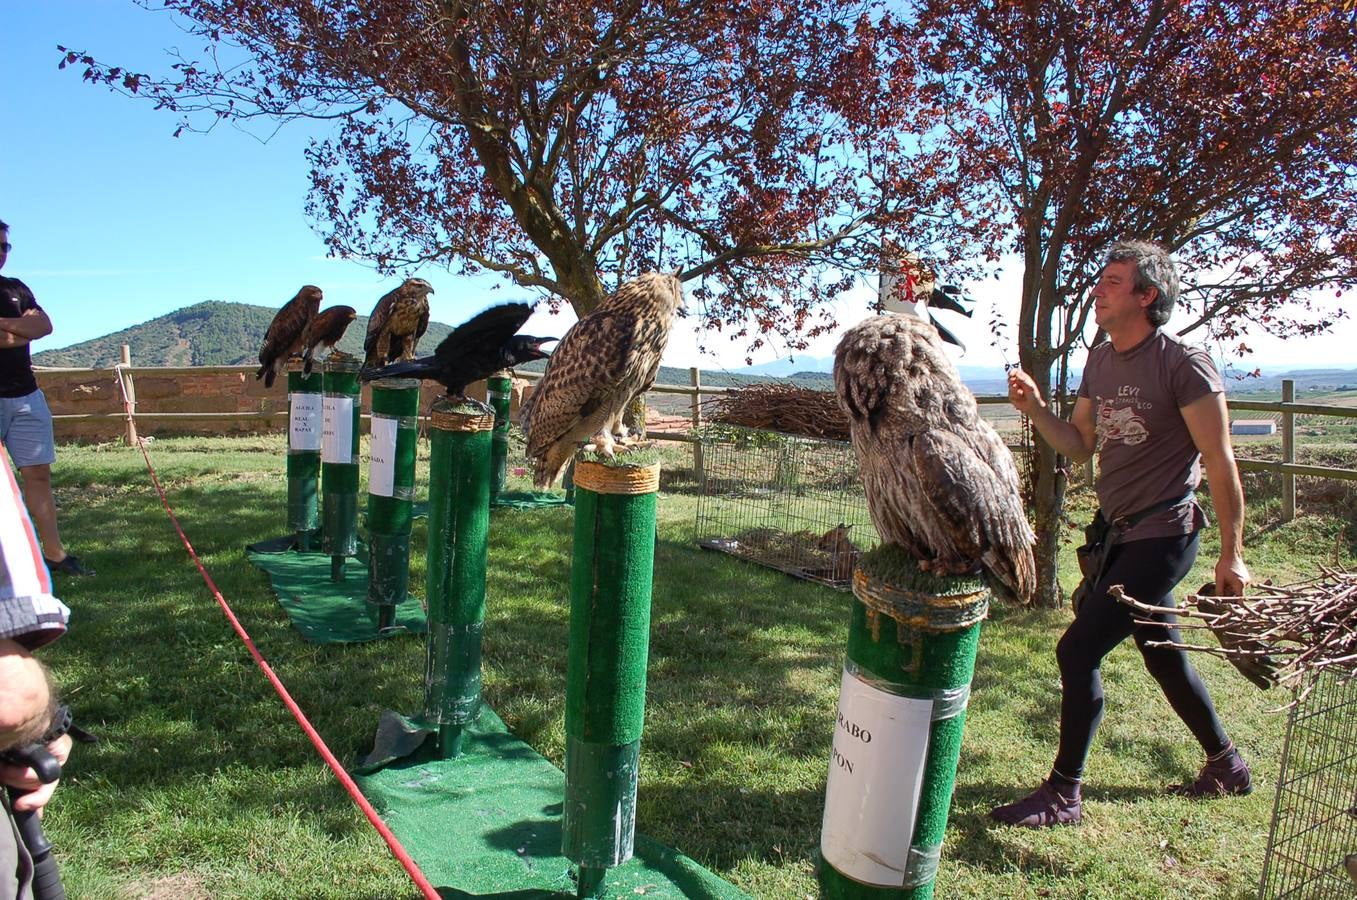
[246,536,429,643]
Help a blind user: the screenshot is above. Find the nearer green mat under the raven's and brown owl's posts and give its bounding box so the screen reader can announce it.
[354,707,746,900]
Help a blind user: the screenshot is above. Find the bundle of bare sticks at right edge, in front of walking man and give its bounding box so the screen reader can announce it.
[1110,567,1357,700]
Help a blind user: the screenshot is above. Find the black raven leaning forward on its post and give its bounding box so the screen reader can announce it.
[362,303,555,399]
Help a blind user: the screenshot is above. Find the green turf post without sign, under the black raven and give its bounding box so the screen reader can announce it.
[423,396,494,759]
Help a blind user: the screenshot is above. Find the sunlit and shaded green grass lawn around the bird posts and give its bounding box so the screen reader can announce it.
[43,436,1357,899]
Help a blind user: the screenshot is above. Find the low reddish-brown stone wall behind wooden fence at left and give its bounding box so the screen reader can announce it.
[35,367,531,441]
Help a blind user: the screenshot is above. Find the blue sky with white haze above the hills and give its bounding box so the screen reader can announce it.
[0,0,1357,369]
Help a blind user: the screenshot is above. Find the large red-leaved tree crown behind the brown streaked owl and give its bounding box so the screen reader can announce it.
[64,0,936,358]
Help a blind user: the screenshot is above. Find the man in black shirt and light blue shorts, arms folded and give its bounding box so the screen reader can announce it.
[0,221,94,576]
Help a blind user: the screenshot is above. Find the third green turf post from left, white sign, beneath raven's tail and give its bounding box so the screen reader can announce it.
[368,379,419,629]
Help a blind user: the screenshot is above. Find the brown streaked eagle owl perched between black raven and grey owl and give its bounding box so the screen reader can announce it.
[521,271,683,489]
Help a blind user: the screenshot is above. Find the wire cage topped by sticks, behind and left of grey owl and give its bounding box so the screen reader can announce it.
[696,425,878,590]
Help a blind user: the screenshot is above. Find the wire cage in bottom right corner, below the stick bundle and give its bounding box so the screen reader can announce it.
[1258,672,1357,900]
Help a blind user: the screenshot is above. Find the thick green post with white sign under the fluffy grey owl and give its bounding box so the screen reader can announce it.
[818,544,989,900]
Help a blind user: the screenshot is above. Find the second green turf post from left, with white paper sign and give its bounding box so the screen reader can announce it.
[320,353,361,581]
